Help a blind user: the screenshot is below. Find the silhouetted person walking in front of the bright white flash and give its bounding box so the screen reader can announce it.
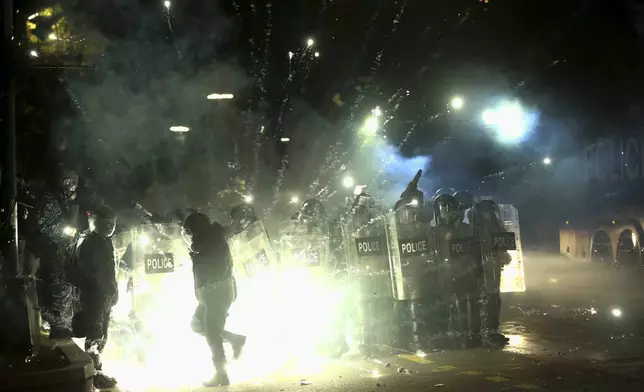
[182,213,246,387]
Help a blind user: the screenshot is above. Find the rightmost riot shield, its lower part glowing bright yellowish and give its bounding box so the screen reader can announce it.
[499,204,526,293]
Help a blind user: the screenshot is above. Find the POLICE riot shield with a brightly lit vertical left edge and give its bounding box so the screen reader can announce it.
[386,208,440,300]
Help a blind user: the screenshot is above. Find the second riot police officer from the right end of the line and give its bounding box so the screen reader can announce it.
[433,194,480,347]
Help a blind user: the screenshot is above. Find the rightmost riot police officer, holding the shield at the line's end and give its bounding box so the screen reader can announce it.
[473,200,511,346]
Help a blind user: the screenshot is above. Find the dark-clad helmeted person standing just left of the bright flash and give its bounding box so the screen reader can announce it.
[69,206,118,389]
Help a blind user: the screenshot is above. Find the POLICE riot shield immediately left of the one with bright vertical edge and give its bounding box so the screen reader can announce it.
[343,219,393,299]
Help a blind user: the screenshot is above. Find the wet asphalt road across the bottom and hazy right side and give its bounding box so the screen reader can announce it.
[115,255,644,392]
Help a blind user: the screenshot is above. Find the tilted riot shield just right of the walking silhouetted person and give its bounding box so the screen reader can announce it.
[228,221,277,281]
